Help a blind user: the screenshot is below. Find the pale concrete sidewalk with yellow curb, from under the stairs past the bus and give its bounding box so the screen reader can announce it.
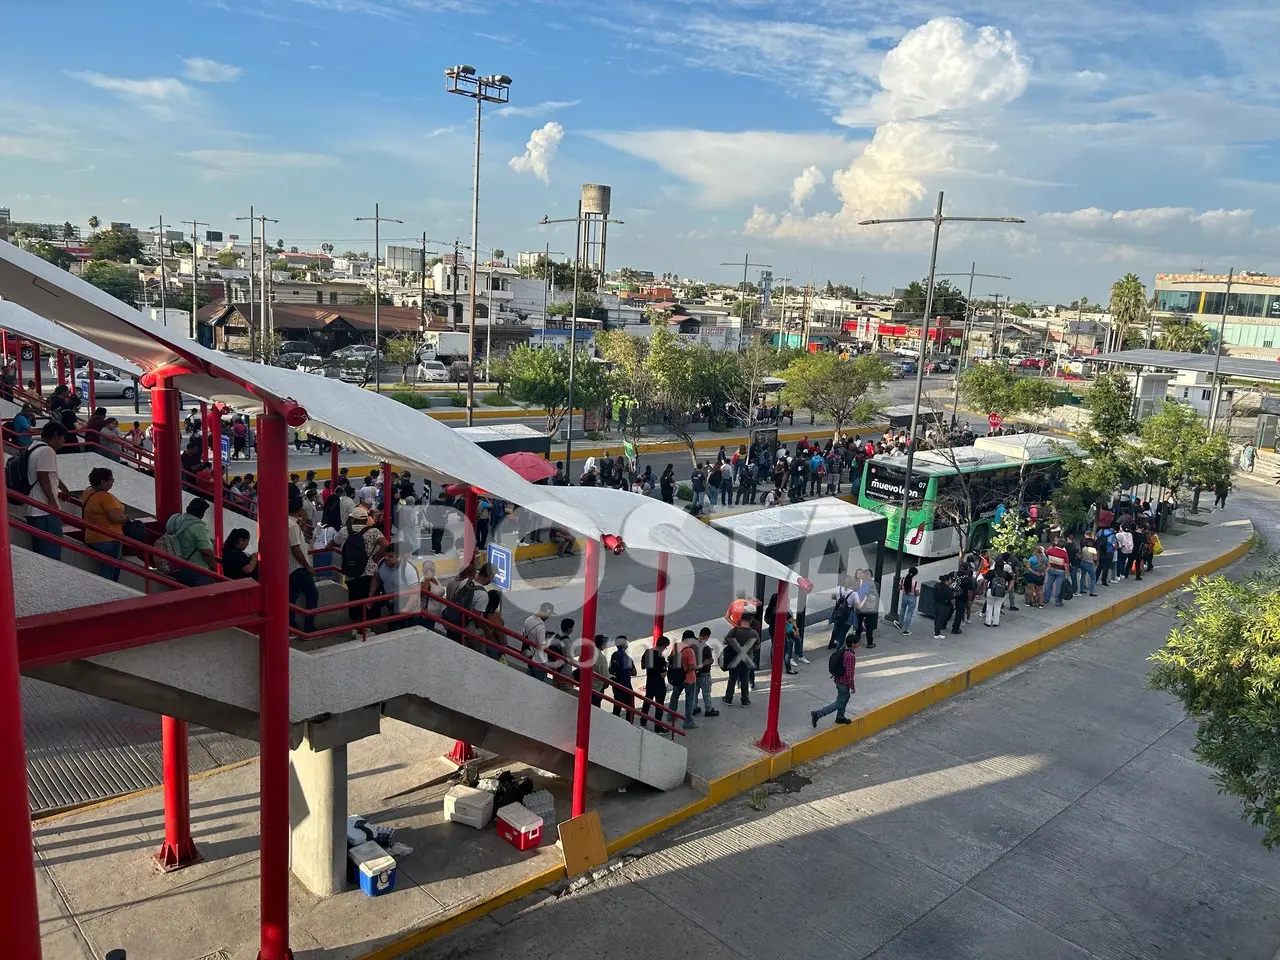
[35,509,1252,960]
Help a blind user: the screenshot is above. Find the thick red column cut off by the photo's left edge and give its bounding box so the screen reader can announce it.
[0,430,40,960]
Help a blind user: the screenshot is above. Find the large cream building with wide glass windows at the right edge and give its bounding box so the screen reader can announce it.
[1155,271,1280,360]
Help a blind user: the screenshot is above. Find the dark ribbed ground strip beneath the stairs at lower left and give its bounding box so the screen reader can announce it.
[22,677,257,815]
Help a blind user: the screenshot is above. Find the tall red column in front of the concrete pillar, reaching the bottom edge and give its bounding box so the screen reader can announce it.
[257,413,293,960]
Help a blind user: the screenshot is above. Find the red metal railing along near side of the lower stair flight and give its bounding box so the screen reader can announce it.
[289,588,687,740]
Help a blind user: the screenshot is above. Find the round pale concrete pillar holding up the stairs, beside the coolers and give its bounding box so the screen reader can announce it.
[289,736,347,897]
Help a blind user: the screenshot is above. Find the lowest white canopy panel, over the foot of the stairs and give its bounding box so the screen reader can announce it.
[549,486,808,584]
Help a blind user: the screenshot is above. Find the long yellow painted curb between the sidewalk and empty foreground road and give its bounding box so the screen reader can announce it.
[360,529,1253,960]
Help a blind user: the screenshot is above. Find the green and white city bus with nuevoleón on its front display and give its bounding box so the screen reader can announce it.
[858,434,1079,559]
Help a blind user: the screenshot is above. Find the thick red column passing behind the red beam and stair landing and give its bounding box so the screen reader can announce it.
[151,378,202,870]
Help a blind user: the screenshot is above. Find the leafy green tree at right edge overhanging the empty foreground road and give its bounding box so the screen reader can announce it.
[1148,562,1280,850]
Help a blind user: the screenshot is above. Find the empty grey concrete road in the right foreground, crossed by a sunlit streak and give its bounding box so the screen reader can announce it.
[410,481,1280,960]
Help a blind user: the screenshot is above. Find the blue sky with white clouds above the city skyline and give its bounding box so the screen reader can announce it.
[0,0,1280,302]
